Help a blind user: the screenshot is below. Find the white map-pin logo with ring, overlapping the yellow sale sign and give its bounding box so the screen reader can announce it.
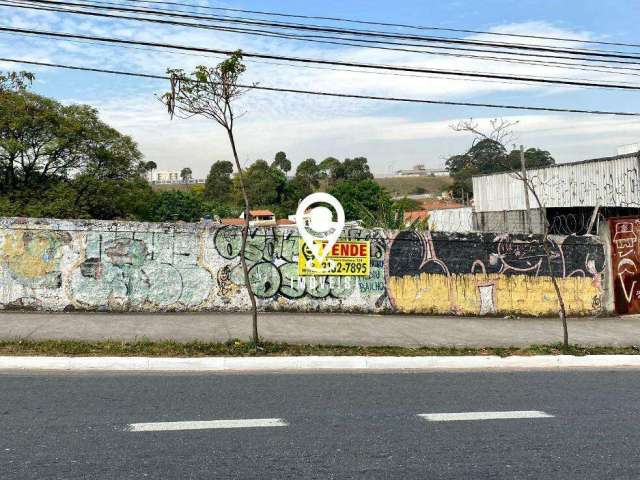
[296,192,344,264]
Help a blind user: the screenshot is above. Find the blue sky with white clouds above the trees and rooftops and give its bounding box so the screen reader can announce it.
[0,0,640,178]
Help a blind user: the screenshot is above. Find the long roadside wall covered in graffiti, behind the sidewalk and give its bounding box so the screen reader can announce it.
[0,218,605,315]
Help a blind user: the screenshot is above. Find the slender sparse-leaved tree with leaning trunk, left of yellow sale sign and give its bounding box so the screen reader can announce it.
[161,50,260,346]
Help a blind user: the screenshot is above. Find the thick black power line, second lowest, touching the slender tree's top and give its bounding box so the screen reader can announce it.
[0,27,640,90]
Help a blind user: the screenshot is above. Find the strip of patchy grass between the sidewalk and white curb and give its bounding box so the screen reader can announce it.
[0,340,640,357]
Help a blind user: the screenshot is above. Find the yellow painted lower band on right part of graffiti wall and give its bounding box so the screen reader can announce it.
[388,273,601,316]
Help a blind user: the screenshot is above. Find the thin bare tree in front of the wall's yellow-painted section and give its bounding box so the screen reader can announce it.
[451,118,569,351]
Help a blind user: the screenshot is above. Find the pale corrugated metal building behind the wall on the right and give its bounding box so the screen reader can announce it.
[473,153,640,233]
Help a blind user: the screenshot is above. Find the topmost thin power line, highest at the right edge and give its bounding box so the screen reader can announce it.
[77,0,640,47]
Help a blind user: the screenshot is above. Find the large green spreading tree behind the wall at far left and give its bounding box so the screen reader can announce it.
[0,74,151,219]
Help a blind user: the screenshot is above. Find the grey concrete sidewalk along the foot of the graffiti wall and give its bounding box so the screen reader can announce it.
[0,312,640,347]
